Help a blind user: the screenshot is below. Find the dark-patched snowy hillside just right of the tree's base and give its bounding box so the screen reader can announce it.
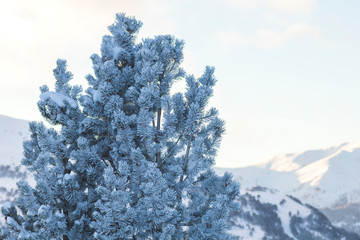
[230,187,360,240]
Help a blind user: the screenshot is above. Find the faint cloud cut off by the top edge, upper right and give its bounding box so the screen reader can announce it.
[225,0,317,14]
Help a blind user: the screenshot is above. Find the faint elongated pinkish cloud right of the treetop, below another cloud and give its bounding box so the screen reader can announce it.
[214,23,323,49]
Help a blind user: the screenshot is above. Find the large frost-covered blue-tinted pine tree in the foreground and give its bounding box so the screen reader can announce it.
[0,14,239,239]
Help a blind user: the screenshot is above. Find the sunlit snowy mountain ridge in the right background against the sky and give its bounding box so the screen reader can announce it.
[216,144,360,208]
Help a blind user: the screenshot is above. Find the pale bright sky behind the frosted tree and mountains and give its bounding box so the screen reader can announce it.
[0,0,360,167]
